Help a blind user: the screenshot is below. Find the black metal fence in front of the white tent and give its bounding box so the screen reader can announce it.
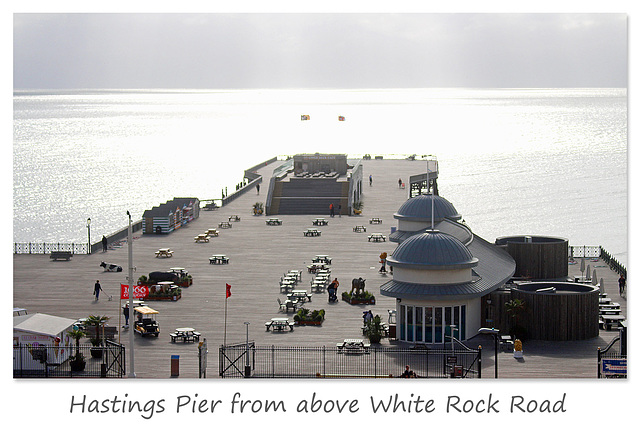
[13,340,126,378]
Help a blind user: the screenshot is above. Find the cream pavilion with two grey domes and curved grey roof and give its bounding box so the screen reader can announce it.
[380,194,516,344]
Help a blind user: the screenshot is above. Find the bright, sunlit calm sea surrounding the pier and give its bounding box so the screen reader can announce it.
[13,89,628,264]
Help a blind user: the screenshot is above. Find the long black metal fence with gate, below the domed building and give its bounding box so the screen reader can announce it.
[219,343,481,378]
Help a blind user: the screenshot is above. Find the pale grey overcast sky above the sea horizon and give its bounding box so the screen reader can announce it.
[13,13,628,89]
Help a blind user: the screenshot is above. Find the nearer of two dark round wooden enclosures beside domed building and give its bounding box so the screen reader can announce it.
[511,281,600,341]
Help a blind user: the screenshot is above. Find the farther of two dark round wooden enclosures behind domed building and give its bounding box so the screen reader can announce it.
[496,236,569,279]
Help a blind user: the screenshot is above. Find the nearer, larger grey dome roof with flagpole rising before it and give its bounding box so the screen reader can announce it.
[387,230,478,269]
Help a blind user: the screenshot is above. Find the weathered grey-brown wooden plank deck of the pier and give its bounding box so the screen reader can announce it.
[13,160,627,379]
